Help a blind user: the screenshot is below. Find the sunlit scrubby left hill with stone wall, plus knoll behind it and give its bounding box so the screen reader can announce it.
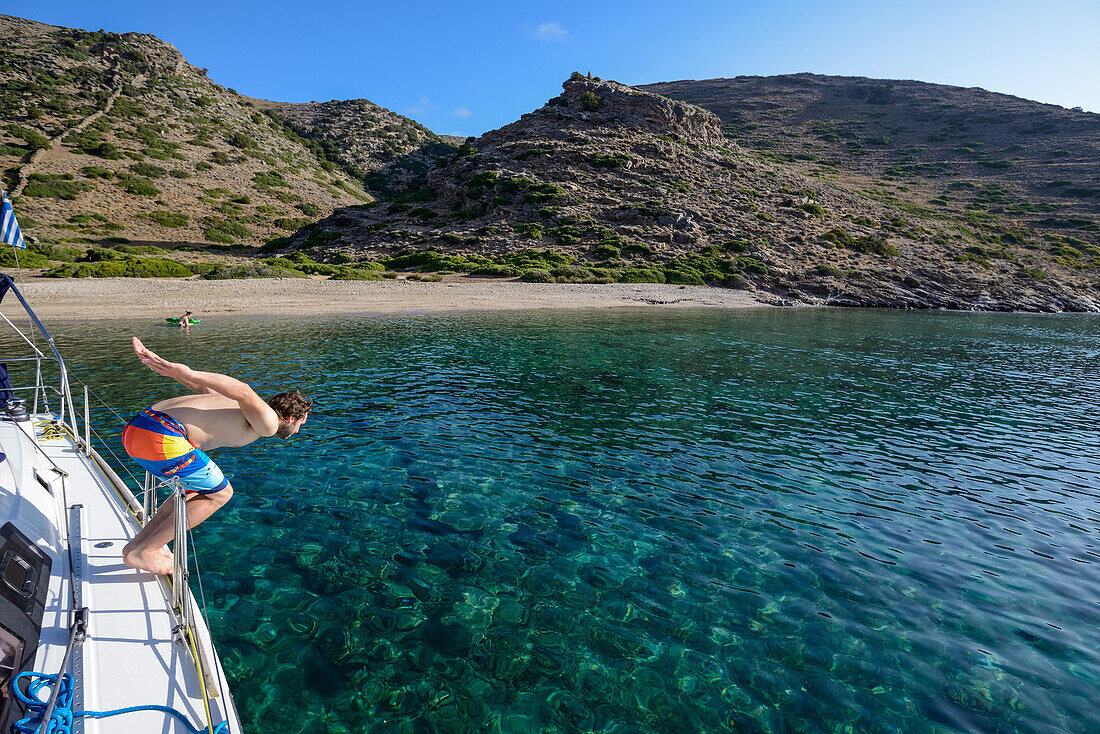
[0,15,433,244]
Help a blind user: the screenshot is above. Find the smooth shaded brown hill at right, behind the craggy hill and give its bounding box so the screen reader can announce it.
[642,74,1100,237]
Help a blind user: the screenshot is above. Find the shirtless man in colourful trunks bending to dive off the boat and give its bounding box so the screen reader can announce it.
[122,337,314,573]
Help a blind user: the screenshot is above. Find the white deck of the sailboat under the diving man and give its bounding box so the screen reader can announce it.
[0,416,240,734]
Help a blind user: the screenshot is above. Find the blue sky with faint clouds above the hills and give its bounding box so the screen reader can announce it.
[8,0,1100,135]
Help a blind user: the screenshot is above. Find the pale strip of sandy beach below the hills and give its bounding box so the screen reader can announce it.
[0,276,767,320]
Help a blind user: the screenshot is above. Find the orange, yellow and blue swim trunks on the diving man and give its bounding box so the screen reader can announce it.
[122,408,229,494]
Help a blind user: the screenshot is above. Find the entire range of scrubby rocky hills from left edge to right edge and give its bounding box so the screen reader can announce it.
[0,17,1100,310]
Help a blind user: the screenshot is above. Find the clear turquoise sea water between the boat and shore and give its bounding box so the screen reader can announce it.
[2,309,1100,733]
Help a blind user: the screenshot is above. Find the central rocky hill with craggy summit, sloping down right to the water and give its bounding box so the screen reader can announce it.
[299,74,1100,310]
